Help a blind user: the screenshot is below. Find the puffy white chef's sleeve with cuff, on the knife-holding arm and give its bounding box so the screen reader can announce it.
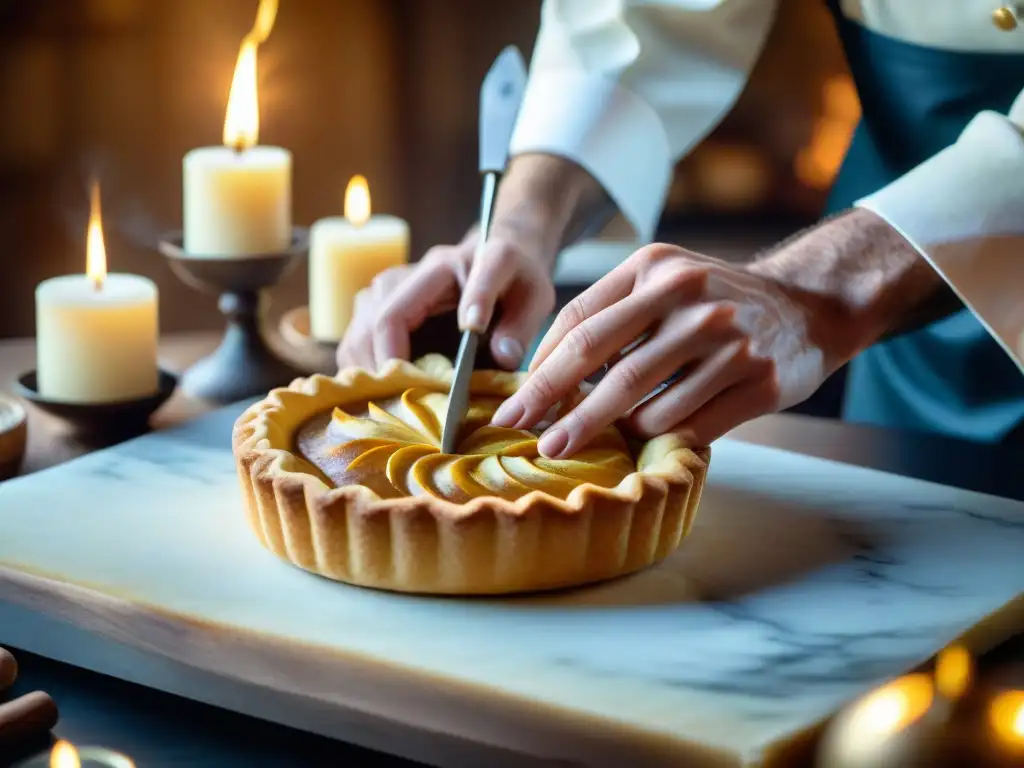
[510,0,775,242]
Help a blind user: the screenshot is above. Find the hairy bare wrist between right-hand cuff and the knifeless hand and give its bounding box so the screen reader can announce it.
[748,209,943,368]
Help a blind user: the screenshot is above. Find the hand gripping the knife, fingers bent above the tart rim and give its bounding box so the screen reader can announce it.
[338,229,555,370]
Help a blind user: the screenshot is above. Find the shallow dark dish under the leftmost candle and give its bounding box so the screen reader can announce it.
[14,369,178,434]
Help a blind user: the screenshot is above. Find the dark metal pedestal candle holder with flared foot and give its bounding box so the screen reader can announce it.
[159,227,308,403]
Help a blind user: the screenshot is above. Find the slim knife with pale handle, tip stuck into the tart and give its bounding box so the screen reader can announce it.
[441,45,526,454]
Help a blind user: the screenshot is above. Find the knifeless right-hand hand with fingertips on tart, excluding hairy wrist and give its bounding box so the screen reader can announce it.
[494,245,833,458]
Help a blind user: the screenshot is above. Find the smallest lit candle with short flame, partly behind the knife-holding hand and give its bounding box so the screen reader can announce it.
[309,176,409,342]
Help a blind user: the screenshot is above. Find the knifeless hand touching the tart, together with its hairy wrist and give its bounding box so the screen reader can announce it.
[494,209,937,458]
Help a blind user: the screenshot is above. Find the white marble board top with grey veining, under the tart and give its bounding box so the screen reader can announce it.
[0,407,1024,765]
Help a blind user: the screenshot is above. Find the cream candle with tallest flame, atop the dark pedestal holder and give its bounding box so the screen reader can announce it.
[182,0,292,257]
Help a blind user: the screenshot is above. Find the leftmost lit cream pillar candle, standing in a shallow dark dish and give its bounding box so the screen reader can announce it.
[36,184,159,402]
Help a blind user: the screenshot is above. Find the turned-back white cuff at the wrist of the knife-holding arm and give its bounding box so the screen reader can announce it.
[509,71,674,242]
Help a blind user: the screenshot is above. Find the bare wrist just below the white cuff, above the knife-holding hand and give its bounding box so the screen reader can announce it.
[490,154,608,270]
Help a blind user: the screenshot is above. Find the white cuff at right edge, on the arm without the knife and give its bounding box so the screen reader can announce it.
[855,91,1024,371]
